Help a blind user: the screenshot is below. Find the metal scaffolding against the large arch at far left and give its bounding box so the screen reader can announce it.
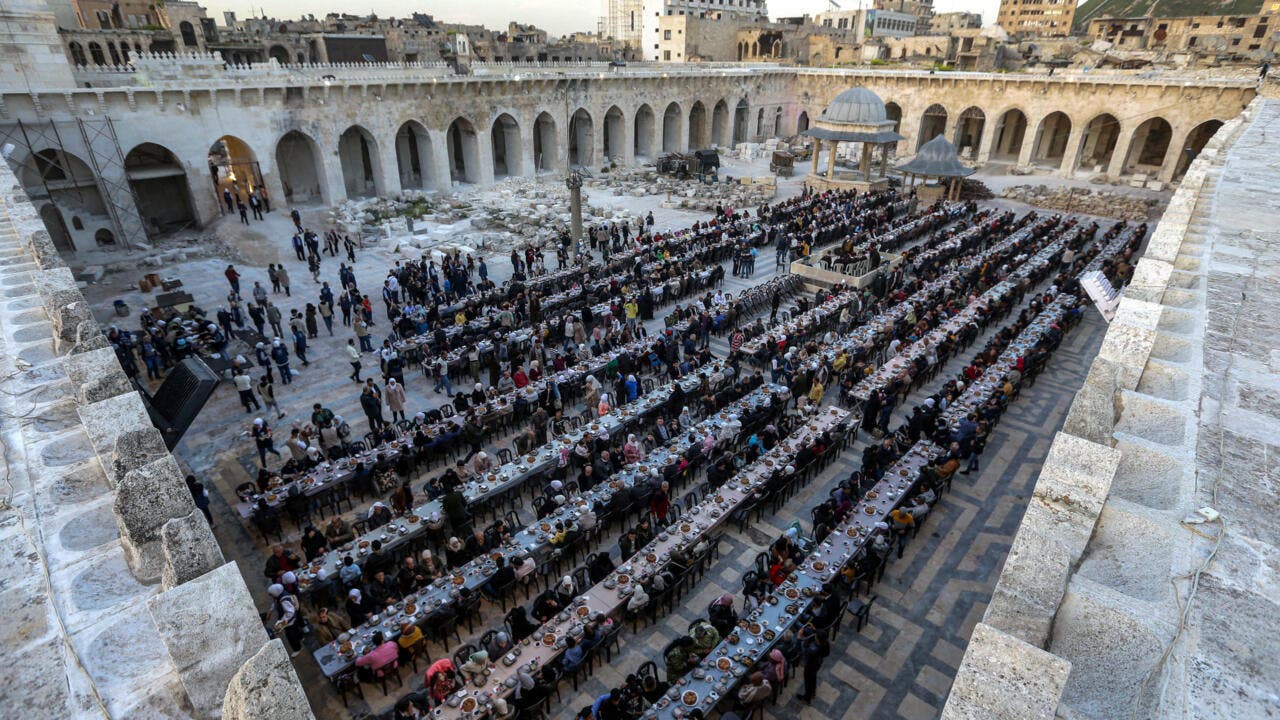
[0,118,147,247]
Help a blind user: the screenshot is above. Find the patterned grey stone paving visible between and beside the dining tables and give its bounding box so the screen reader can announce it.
[170,210,1102,719]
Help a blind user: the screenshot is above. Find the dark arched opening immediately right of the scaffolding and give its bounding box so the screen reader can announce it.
[124,142,196,234]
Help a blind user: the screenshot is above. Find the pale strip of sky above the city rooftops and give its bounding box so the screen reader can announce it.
[202,0,1000,36]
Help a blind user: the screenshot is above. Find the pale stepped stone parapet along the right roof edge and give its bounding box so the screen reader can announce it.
[942,101,1258,720]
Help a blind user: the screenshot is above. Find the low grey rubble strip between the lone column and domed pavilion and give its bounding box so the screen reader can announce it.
[584,168,777,210]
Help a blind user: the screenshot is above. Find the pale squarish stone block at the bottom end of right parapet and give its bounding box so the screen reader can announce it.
[942,623,1071,720]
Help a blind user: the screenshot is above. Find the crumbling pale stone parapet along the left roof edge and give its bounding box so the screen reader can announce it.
[0,164,311,720]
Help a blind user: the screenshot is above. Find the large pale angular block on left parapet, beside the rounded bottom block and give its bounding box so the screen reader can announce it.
[147,561,275,717]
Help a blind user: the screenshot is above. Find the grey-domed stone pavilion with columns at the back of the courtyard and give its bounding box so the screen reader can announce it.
[801,87,904,191]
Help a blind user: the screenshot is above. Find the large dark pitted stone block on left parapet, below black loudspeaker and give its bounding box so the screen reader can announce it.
[114,456,196,582]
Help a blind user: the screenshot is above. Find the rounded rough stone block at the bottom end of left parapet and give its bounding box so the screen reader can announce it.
[223,638,315,720]
